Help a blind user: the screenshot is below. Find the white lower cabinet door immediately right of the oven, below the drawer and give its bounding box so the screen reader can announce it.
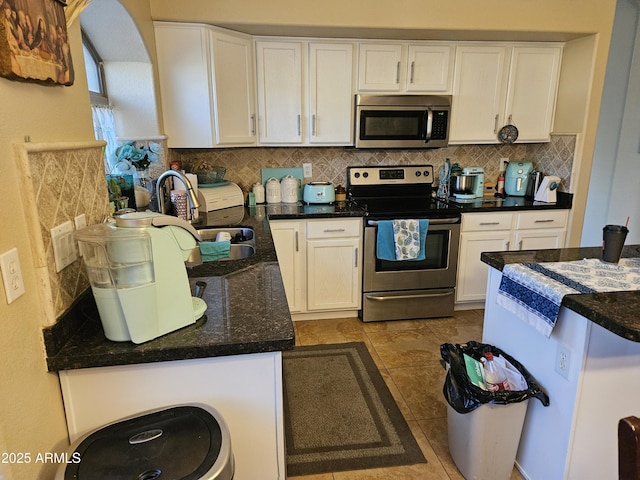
[456,230,511,302]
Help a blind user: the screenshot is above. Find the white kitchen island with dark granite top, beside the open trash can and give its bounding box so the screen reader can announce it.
[482,245,640,480]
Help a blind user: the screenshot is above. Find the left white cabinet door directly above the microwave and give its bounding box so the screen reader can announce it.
[358,43,402,92]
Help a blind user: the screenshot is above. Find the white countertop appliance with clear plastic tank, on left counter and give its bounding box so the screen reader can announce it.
[76,212,207,344]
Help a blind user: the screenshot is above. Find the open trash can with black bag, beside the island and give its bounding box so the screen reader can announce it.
[440,341,549,480]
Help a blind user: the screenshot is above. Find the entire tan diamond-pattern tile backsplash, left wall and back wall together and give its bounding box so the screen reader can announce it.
[16,135,576,325]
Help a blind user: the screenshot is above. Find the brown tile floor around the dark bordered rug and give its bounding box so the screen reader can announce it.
[294,310,523,480]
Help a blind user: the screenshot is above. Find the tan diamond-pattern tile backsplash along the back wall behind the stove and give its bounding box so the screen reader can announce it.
[169,135,576,192]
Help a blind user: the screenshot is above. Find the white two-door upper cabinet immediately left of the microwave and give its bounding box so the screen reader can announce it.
[256,40,353,145]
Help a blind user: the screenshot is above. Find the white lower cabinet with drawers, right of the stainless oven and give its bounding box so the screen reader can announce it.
[456,210,568,304]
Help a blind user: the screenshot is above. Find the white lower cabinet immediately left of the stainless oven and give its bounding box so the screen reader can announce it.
[269,218,362,318]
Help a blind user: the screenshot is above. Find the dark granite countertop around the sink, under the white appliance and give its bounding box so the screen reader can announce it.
[43,207,295,371]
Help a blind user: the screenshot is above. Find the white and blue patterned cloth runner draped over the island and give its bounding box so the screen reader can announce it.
[496,258,640,337]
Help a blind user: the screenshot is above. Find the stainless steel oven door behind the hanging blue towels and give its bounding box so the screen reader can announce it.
[363,216,460,292]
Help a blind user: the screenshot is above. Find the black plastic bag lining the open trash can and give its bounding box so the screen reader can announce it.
[440,341,549,413]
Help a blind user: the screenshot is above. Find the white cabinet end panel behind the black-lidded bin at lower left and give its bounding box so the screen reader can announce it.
[59,352,286,480]
